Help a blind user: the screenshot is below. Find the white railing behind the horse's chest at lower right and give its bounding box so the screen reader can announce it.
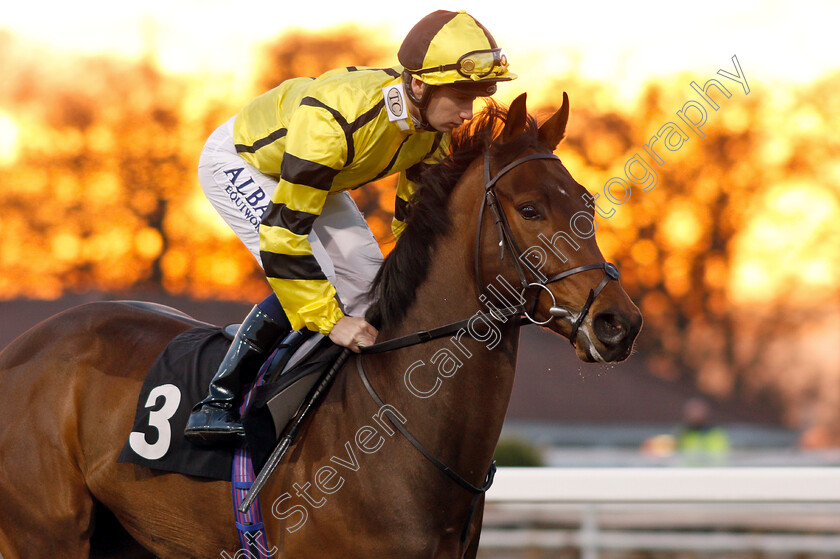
[481,468,840,559]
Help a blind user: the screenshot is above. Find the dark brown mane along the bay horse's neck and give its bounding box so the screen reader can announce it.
[366,100,539,329]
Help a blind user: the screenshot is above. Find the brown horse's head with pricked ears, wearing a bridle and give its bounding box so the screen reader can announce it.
[465,93,642,362]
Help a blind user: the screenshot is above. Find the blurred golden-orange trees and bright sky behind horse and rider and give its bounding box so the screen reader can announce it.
[0,1,840,442]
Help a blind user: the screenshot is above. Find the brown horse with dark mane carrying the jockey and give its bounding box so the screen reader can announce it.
[0,95,641,559]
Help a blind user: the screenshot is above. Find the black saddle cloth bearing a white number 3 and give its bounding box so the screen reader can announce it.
[117,326,342,481]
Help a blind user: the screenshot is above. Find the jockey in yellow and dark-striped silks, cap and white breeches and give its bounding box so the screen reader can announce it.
[185,10,516,443]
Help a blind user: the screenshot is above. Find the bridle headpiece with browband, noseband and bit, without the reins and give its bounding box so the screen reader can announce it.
[475,150,621,345]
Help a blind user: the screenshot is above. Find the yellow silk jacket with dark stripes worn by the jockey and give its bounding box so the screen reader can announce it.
[234,67,449,334]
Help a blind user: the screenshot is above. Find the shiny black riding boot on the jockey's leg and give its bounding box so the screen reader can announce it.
[184,306,289,444]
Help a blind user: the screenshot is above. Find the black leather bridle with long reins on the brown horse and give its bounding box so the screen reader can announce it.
[356,150,620,544]
